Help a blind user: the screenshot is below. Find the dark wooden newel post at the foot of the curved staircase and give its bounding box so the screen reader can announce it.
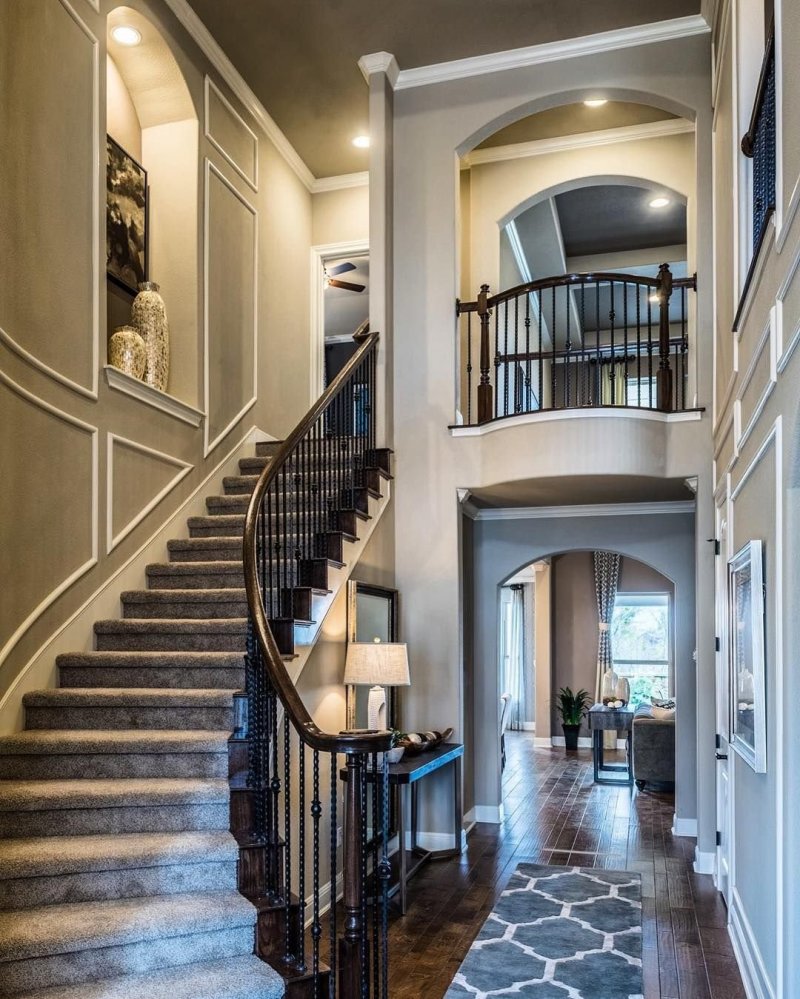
[339,753,367,999]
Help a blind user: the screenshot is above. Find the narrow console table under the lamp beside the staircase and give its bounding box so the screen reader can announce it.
[340,742,464,915]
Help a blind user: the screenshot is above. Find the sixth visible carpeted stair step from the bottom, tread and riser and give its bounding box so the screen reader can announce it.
[23,687,235,731]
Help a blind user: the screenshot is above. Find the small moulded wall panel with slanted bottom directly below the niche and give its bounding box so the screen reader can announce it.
[106,434,194,552]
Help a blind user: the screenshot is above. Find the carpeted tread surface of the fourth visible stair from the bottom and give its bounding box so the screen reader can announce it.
[0,777,230,812]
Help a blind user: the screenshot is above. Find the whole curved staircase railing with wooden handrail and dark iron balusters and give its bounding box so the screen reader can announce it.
[244,324,391,999]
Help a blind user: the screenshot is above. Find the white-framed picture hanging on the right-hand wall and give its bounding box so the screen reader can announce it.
[728,541,767,773]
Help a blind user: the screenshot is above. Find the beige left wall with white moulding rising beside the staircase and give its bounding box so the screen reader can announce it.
[0,0,312,728]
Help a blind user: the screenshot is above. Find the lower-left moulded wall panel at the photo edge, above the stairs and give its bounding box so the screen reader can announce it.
[0,371,98,664]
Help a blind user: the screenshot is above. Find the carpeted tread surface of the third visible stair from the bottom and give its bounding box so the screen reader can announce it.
[0,830,239,878]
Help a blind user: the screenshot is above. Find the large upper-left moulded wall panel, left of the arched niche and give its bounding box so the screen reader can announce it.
[0,0,100,398]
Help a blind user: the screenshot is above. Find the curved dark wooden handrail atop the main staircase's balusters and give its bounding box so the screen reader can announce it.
[244,323,392,753]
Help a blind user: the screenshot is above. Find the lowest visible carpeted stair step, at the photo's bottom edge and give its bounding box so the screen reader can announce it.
[7,954,284,999]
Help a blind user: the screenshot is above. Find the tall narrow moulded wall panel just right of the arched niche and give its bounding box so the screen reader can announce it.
[204,160,258,454]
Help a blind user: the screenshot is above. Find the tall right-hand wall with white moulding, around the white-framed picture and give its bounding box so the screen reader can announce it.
[714,0,800,999]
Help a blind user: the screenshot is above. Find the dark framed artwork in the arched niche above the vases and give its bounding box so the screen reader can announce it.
[106,135,147,295]
